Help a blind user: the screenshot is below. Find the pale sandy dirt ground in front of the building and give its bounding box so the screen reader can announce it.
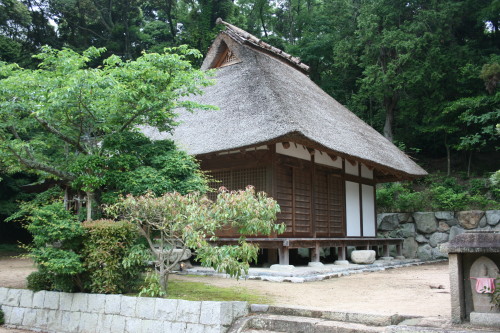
[0,257,450,318]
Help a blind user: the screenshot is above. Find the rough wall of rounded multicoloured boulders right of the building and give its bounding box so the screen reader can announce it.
[377,210,500,260]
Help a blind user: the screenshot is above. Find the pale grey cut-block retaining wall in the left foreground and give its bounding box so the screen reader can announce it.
[0,288,248,333]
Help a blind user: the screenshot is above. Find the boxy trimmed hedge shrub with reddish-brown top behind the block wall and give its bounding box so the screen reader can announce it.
[83,220,147,294]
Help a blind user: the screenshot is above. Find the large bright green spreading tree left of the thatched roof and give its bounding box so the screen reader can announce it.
[0,47,215,219]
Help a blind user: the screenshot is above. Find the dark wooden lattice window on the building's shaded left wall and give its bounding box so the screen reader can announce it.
[209,168,266,200]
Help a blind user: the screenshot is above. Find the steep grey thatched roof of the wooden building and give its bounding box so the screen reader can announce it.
[144,22,426,179]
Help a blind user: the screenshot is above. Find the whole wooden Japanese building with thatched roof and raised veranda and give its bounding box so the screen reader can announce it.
[145,20,427,265]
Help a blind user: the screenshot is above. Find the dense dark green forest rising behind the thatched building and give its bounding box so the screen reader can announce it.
[0,0,500,241]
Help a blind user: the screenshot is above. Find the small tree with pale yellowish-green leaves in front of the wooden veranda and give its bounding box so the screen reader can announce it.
[108,186,285,293]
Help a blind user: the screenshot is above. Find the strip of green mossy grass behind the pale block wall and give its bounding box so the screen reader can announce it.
[167,280,272,304]
